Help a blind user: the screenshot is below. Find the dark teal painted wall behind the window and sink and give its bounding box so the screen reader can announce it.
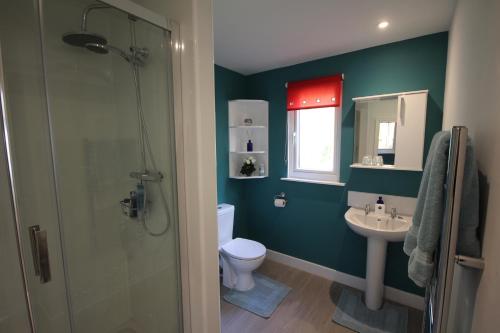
[216,33,448,294]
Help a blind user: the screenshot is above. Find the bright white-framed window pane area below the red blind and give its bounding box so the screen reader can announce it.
[288,107,341,182]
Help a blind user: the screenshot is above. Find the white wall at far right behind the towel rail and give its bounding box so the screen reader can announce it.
[443,0,500,332]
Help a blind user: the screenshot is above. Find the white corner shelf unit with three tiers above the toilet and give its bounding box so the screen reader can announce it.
[228,99,269,179]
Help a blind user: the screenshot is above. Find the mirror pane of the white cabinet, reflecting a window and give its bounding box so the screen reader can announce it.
[354,97,398,165]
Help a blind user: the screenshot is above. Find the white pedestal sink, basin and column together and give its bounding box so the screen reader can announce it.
[344,207,412,310]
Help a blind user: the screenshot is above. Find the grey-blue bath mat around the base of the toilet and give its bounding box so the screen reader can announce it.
[224,273,291,318]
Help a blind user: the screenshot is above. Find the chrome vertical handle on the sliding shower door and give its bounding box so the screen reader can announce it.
[29,225,51,283]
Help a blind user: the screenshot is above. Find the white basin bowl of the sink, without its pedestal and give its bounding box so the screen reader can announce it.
[344,207,412,242]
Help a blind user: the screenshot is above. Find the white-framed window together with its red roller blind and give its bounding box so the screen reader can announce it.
[285,74,344,185]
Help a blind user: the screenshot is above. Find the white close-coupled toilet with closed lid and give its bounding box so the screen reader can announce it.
[217,204,266,291]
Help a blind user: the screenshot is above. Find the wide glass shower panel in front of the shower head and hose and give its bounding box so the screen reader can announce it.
[42,0,181,332]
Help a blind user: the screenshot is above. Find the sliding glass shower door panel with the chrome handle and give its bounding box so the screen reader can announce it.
[0,0,70,333]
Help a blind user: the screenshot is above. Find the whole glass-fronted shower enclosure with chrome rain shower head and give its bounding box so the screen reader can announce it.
[0,0,182,333]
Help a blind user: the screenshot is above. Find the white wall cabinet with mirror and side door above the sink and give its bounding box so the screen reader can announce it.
[351,90,428,171]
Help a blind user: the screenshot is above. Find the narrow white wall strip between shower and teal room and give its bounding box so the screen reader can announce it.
[134,0,220,332]
